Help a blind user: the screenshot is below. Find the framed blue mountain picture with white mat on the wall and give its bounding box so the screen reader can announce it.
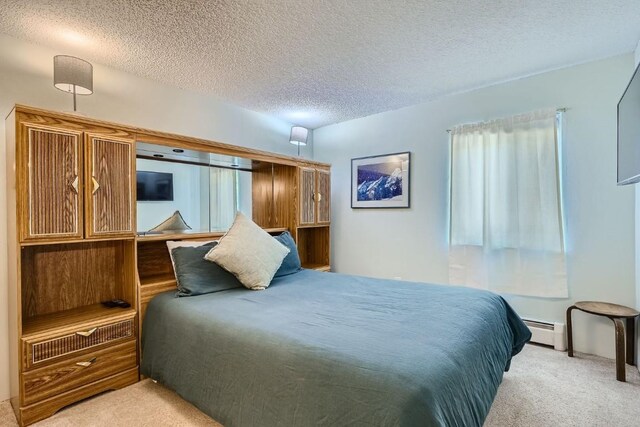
[351,151,411,209]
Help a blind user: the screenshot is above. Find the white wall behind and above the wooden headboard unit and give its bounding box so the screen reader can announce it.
[0,36,313,401]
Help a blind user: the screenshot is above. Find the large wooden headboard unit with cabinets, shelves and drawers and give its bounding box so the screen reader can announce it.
[2,105,331,425]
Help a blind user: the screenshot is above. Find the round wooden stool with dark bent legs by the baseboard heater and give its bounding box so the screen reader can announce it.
[567,301,640,381]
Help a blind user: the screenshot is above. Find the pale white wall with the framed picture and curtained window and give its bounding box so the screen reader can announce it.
[314,55,635,357]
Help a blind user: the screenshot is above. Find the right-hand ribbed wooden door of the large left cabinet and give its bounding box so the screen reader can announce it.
[85,134,135,238]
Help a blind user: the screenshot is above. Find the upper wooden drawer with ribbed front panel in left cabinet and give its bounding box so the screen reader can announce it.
[23,318,135,369]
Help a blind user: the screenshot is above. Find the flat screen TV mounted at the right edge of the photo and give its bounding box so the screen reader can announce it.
[618,65,640,185]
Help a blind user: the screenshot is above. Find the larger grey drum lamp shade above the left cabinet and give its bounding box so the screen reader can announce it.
[53,55,93,95]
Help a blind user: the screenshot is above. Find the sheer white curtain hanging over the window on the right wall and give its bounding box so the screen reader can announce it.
[449,110,568,298]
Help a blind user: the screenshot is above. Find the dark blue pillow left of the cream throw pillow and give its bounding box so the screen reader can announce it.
[171,242,242,297]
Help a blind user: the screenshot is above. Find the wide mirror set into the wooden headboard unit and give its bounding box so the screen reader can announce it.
[136,142,254,235]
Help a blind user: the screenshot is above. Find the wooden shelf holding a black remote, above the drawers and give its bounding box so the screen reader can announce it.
[22,304,136,339]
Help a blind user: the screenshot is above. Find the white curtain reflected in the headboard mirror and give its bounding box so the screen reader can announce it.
[209,168,237,231]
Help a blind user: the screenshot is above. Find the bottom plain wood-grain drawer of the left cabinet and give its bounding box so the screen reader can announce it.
[22,339,137,406]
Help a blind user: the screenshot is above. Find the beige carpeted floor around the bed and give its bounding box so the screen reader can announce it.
[0,345,640,427]
